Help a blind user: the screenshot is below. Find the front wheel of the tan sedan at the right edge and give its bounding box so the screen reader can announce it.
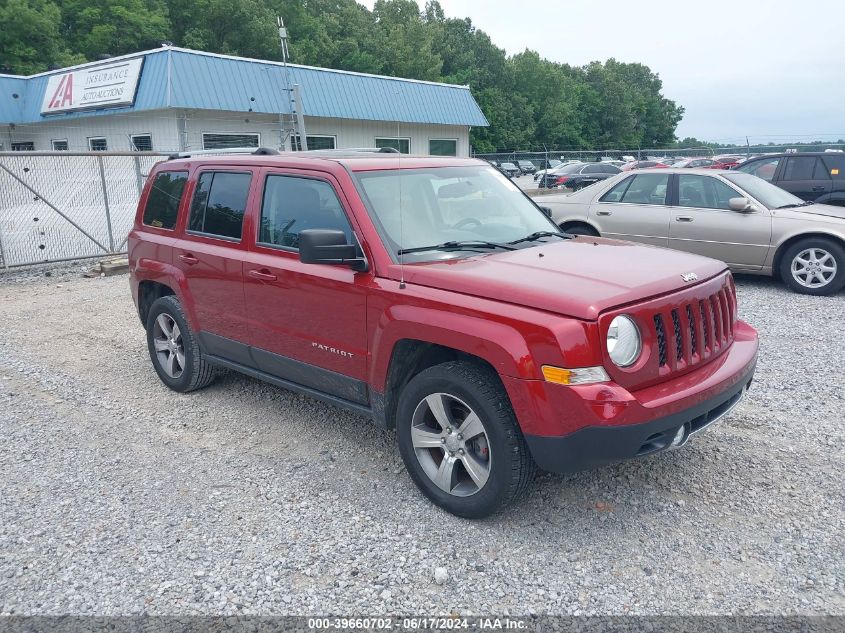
[780,237,845,295]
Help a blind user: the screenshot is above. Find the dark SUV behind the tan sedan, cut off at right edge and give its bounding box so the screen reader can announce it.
[735,152,845,207]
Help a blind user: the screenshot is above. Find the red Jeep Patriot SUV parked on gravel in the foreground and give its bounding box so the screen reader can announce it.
[129,151,757,517]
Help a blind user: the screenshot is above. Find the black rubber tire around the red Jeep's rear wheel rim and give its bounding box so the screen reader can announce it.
[147,295,215,393]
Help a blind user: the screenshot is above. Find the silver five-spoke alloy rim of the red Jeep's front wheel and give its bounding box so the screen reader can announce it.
[411,393,492,497]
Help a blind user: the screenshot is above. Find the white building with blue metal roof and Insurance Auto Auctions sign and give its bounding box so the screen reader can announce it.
[0,47,488,156]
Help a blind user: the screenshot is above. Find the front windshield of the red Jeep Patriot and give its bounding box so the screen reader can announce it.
[355,165,560,262]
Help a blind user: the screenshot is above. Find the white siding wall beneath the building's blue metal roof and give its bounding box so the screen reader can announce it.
[0,110,469,156]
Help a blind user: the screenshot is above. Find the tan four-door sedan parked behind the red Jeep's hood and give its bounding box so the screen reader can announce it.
[538,168,845,295]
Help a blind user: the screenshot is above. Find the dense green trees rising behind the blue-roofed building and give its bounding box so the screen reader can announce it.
[0,0,683,152]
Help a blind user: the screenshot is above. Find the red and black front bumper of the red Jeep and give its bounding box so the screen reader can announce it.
[505,321,758,473]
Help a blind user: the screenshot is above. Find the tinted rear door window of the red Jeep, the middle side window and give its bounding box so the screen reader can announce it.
[188,171,252,240]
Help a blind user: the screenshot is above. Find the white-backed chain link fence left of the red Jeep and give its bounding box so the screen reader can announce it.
[0,152,165,268]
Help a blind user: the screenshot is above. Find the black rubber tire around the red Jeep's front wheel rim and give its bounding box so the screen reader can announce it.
[396,361,536,519]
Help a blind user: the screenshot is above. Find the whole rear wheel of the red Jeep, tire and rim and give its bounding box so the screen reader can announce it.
[147,295,214,392]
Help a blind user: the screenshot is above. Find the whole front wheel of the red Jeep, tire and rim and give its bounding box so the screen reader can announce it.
[396,361,536,519]
